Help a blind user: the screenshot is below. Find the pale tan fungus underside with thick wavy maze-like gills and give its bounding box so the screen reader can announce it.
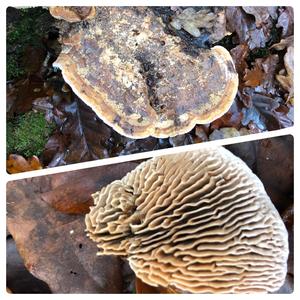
[85,147,288,293]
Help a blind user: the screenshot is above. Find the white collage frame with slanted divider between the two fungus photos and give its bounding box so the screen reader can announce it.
[0,0,300,300]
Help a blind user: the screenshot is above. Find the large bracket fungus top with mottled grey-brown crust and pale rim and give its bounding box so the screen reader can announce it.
[54,7,238,138]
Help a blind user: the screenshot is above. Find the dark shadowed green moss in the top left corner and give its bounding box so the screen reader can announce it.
[6,7,52,80]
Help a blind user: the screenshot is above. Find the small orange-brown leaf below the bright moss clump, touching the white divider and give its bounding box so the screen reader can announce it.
[6,154,43,174]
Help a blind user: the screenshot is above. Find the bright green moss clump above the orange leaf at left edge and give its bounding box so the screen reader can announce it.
[6,112,55,157]
